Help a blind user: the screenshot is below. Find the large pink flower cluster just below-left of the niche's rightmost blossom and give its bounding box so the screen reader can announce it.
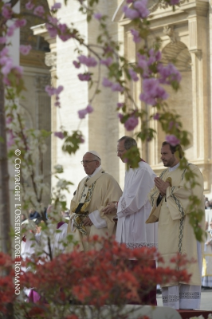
[139,78,168,105]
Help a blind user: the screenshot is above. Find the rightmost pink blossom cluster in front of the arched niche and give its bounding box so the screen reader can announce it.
[158,63,182,84]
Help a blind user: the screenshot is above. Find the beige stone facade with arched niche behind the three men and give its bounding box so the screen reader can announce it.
[30,0,212,202]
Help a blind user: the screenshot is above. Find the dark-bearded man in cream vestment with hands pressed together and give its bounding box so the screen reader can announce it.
[147,142,204,309]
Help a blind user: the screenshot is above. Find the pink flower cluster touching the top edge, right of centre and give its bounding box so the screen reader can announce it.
[123,0,149,20]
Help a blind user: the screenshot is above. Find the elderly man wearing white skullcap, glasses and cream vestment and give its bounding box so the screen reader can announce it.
[68,151,122,251]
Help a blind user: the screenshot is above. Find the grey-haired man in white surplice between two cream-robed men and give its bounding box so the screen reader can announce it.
[104,136,157,305]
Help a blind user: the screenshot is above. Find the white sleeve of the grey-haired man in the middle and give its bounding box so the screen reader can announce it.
[117,168,155,218]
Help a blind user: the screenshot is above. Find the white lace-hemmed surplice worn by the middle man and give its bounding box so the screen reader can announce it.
[116,161,158,248]
